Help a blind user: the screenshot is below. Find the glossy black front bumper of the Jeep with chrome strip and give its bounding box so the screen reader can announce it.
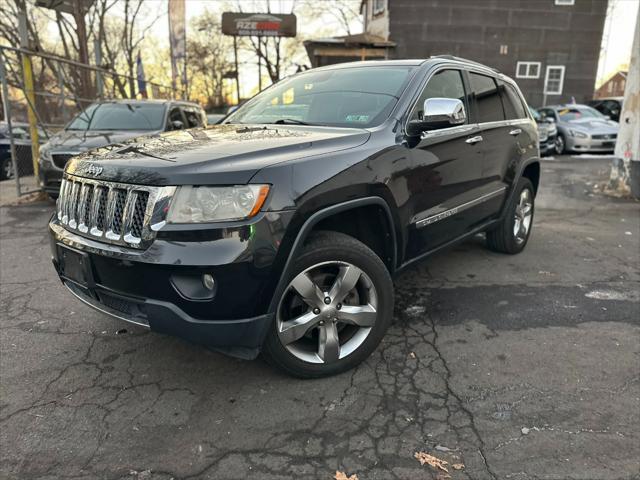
[49,211,293,358]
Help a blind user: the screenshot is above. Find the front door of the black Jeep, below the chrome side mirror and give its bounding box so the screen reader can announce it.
[405,68,482,260]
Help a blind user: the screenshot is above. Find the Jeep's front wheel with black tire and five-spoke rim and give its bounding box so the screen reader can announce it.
[263,232,394,378]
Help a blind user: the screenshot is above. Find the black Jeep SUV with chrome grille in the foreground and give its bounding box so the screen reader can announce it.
[49,57,540,377]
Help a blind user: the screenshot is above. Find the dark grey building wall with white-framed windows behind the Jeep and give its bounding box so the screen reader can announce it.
[388,0,607,107]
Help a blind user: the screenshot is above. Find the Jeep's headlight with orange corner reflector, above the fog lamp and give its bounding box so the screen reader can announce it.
[167,185,269,223]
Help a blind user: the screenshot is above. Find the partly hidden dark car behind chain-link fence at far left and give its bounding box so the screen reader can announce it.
[0,122,47,180]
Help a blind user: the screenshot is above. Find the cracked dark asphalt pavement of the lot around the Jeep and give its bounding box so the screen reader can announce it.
[0,157,640,480]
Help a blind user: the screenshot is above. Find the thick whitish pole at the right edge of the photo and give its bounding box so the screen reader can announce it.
[610,5,640,198]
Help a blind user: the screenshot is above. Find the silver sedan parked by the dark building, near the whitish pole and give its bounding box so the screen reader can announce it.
[538,103,618,155]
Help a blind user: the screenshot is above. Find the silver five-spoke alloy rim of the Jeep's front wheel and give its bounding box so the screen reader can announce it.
[276,261,378,363]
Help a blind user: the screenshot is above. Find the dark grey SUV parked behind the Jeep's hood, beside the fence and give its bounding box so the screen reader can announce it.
[39,100,206,198]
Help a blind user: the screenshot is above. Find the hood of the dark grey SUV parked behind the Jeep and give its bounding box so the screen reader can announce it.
[46,130,159,153]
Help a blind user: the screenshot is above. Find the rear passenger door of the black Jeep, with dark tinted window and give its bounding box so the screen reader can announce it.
[468,71,510,221]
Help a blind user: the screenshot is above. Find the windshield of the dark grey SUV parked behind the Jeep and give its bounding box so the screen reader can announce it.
[67,103,165,130]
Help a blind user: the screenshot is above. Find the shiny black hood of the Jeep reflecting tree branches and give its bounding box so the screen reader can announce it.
[66,124,370,185]
